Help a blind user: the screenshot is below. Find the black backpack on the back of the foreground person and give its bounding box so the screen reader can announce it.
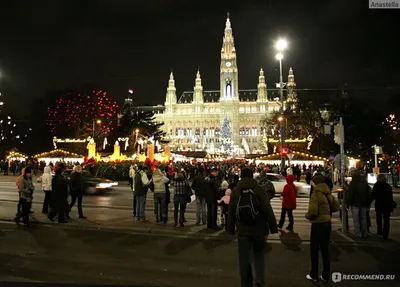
[236,189,260,225]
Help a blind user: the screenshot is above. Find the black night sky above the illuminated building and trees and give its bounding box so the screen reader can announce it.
[0,0,400,115]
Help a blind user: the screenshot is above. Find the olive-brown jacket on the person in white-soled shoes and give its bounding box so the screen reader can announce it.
[306,183,339,223]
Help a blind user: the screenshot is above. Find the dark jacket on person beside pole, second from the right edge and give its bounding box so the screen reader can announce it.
[347,175,371,207]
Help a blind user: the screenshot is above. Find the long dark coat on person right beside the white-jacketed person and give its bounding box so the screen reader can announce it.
[51,175,68,213]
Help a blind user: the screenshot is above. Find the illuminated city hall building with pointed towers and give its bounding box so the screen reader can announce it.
[130,16,296,152]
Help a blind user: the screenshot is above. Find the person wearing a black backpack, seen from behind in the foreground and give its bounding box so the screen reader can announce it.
[228,168,278,287]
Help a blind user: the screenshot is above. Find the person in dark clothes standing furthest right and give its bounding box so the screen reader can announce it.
[371,174,397,239]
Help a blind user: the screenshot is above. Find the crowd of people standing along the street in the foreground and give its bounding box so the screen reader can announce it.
[7,161,396,286]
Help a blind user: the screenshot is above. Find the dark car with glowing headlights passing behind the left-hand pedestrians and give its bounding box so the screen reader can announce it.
[64,169,118,195]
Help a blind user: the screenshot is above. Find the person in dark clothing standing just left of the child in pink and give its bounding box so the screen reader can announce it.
[206,167,220,229]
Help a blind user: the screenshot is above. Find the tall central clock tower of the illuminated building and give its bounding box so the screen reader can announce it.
[220,14,239,102]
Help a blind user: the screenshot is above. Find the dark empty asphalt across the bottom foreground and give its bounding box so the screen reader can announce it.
[0,223,400,287]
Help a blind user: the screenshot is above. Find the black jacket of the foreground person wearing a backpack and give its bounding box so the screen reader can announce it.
[228,178,278,236]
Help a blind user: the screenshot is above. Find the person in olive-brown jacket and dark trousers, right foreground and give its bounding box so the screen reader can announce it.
[306,175,339,282]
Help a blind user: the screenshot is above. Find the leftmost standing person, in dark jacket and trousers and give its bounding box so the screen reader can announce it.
[14,167,35,227]
